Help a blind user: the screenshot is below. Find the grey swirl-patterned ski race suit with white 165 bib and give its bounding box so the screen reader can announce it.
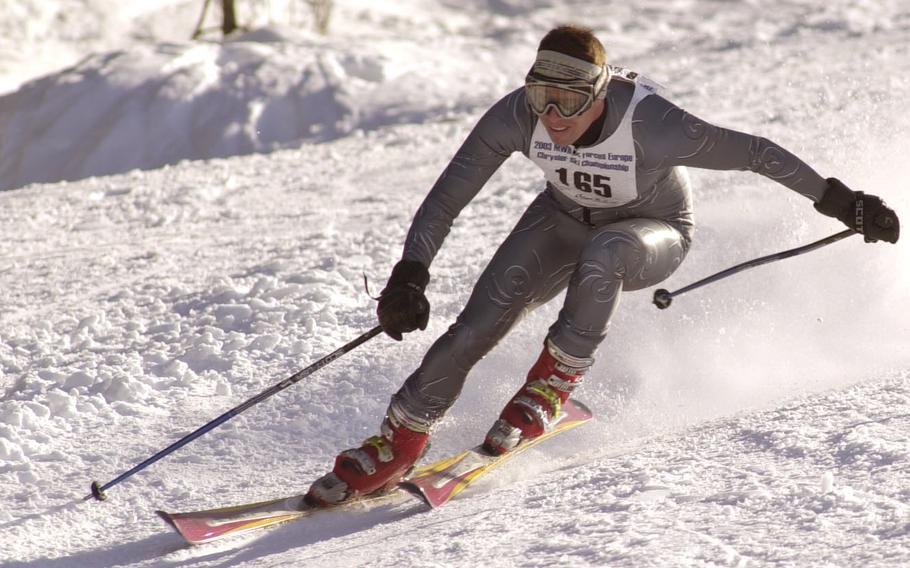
[389,69,827,431]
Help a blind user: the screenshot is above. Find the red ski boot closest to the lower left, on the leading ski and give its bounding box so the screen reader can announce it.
[306,416,430,507]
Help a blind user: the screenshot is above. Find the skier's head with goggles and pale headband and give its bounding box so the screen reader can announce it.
[525,25,610,144]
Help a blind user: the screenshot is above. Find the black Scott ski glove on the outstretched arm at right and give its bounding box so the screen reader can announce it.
[815,178,901,243]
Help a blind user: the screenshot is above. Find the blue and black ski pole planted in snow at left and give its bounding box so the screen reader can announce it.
[82,325,382,501]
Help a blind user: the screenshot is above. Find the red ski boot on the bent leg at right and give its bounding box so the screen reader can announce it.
[483,339,594,455]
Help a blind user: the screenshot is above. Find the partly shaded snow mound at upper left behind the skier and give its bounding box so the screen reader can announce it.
[0,25,528,190]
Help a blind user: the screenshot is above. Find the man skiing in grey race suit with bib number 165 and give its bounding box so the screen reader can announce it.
[307,26,899,506]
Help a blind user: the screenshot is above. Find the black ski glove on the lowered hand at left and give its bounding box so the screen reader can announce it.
[376,260,430,341]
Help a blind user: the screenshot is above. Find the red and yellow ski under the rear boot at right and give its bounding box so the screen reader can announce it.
[398,400,592,509]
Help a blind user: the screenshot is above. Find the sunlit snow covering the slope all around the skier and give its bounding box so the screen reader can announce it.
[0,0,910,568]
